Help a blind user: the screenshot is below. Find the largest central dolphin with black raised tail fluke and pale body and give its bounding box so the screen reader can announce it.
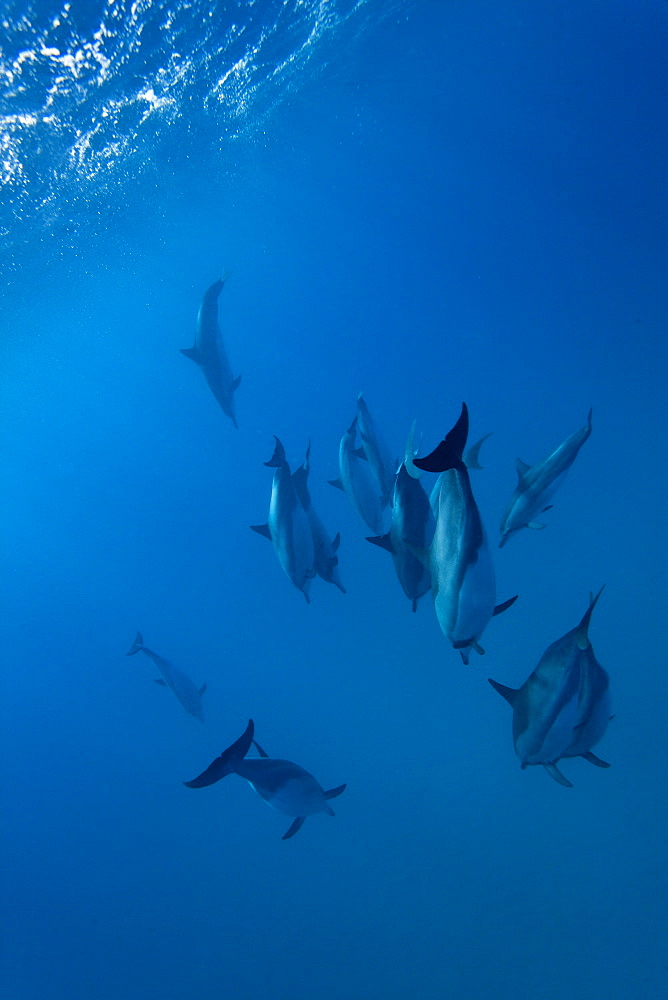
[413,403,517,663]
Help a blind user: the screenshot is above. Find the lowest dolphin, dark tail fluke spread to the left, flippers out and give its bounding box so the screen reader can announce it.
[184,719,346,840]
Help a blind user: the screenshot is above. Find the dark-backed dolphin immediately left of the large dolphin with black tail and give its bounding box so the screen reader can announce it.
[367,423,436,611]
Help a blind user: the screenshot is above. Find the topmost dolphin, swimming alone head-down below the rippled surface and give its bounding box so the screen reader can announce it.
[181,274,241,427]
